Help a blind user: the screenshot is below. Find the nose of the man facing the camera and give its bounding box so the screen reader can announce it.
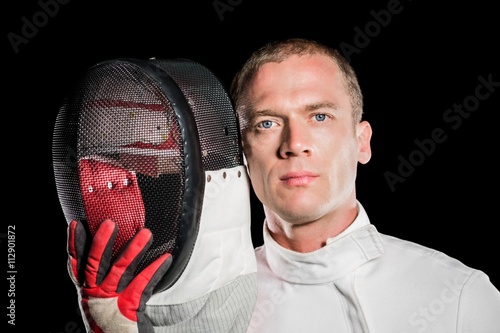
[279,120,313,158]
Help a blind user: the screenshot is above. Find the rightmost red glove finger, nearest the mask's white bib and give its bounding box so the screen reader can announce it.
[118,253,172,321]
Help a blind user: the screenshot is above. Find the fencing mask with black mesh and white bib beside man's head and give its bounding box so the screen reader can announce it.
[53,59,256,332]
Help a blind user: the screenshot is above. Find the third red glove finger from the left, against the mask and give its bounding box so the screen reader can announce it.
[101,228,152,293]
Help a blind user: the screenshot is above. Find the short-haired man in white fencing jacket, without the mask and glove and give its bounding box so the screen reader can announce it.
[231,39,500,333]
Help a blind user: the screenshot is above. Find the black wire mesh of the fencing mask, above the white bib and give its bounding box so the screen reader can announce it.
[53,60,242,284]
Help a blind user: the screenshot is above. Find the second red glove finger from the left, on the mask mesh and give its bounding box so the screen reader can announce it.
[85,219,118,288]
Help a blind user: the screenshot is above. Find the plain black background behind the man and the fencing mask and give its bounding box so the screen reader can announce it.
[4,0,500,333]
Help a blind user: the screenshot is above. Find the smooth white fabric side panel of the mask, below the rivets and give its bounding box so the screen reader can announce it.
[147,166,257,305]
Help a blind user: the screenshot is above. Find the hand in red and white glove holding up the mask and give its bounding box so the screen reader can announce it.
[68,219,172,333]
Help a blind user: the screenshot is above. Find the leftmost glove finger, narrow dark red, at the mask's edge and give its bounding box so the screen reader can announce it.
[67,220,87,284]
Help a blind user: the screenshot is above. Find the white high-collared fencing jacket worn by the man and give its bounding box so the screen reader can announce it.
[248,202,500,333]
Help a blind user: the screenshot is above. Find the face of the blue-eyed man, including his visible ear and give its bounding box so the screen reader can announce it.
[243,55,371,224]
